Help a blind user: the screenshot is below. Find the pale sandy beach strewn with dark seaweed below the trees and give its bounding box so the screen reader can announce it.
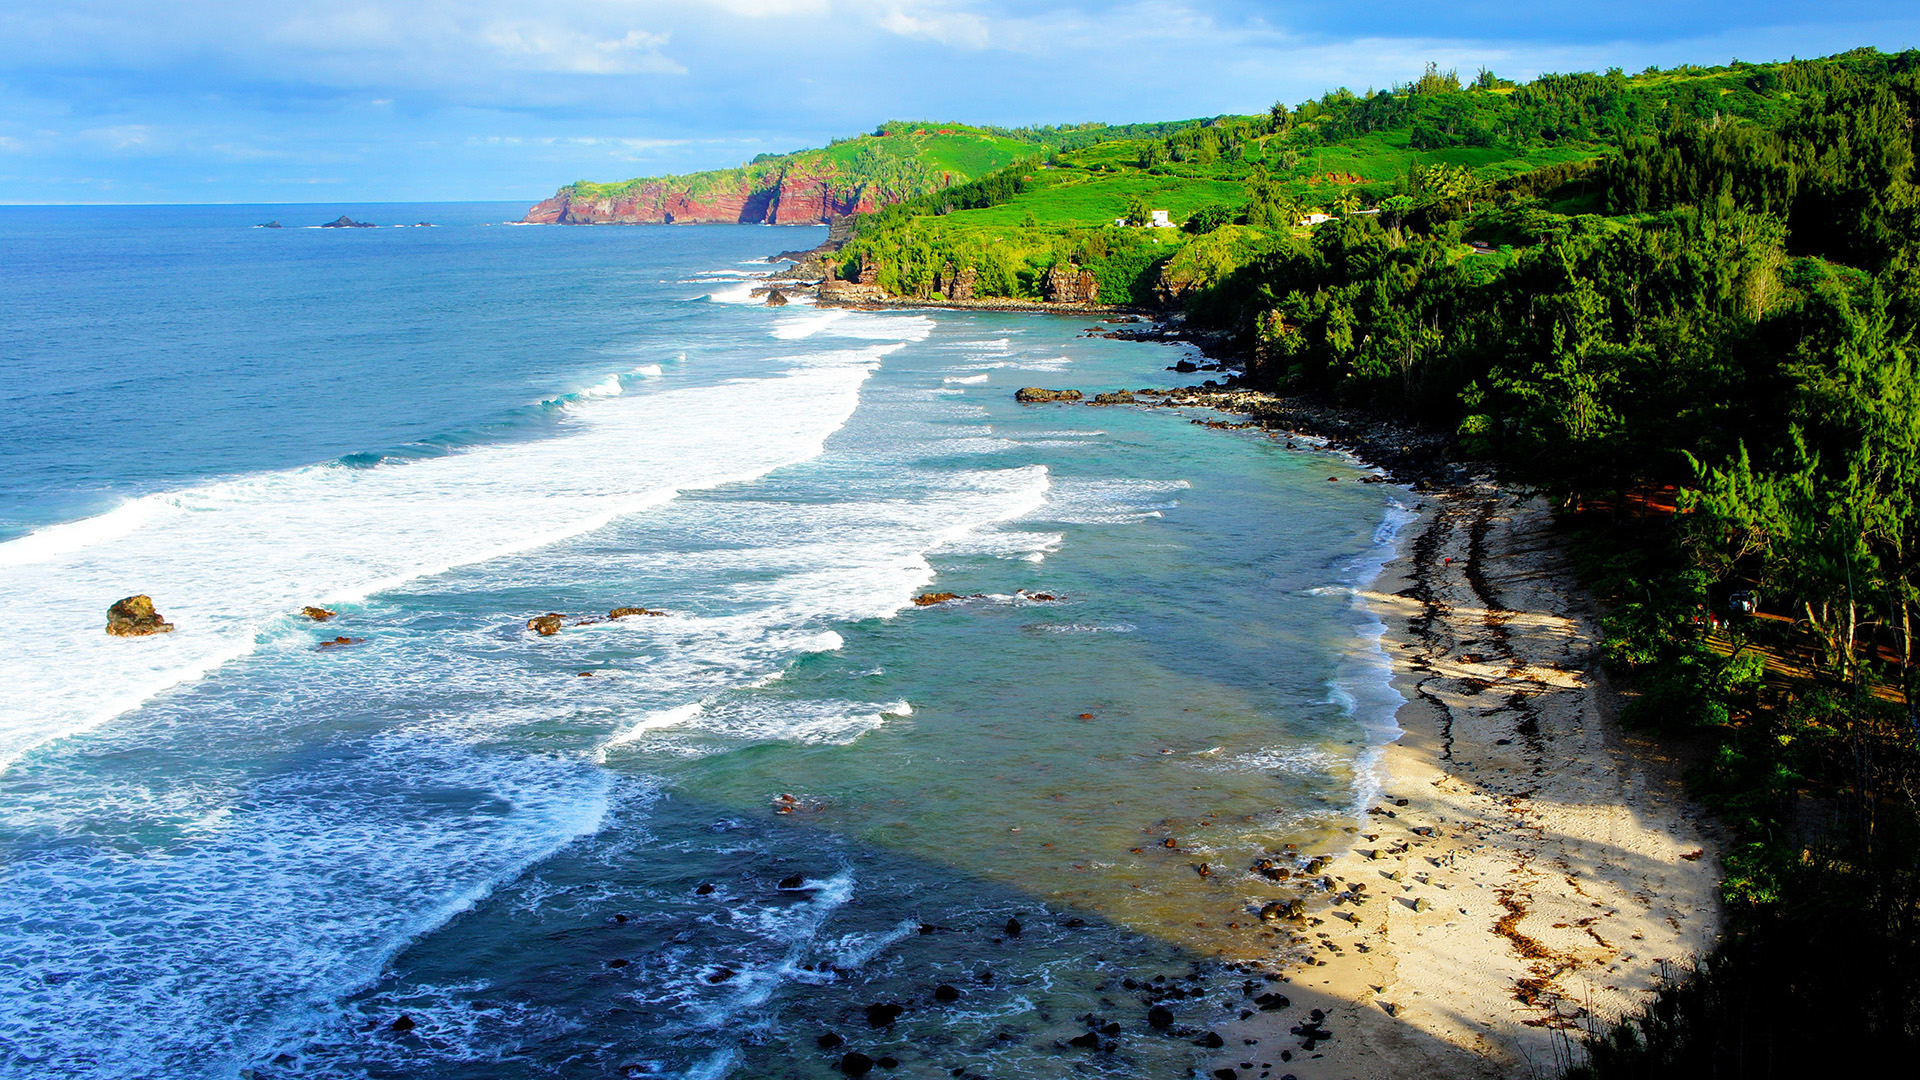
[1210,486,1720,1080]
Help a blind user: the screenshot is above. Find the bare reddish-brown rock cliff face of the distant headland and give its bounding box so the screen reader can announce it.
[524,161,891,225]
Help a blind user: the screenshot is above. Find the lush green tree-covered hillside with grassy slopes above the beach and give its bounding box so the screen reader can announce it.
[843,50,1920,1078]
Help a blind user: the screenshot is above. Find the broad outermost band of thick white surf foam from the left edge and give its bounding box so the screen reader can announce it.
[0,346,899,769]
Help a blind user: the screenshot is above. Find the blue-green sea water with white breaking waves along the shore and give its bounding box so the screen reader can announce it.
[0,204,1407,1078]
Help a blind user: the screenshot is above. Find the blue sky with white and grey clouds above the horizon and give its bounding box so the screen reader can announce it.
[0,0,1920,204]
